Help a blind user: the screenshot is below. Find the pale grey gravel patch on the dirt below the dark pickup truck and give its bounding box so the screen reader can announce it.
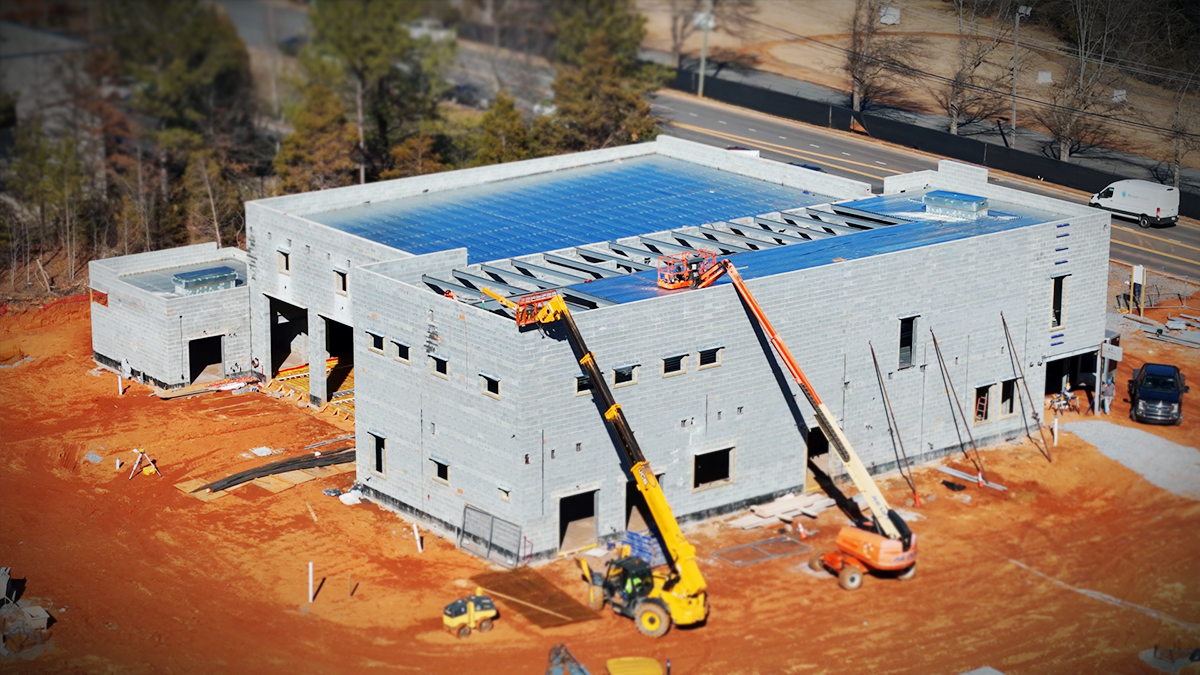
[1062,420,1200,501]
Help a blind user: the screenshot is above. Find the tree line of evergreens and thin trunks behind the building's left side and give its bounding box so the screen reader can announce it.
[0,0,665,291]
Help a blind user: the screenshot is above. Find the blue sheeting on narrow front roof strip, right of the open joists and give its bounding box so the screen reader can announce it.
[581,191,1063,304]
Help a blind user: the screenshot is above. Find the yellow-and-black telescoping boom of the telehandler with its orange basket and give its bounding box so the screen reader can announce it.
[482,288,708,634]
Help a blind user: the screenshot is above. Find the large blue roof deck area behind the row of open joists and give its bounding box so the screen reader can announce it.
[306,155,833,263]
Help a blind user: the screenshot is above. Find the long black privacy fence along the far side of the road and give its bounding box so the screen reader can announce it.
[670,70,1200,217]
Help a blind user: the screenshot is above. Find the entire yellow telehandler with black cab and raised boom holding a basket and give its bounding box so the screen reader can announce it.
[482,288,708,638]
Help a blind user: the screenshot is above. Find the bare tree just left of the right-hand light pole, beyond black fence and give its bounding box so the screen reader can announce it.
[932,0,1014,135]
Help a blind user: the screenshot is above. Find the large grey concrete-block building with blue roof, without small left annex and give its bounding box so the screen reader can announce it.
[88,137,1110,565]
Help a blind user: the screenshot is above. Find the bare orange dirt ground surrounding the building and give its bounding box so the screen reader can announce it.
[0,303,1200,675]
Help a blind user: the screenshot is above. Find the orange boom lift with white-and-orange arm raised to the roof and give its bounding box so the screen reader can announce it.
[659,251,917,591]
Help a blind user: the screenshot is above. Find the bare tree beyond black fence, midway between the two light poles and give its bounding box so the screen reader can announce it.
[842,0,925,110]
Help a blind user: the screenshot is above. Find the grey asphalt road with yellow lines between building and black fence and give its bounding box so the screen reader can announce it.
[654,91,1200,279]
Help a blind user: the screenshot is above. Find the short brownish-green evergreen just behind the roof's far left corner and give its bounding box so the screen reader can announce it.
[275,86,355,192]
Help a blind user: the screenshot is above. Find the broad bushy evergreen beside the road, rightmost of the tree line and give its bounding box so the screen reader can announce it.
[535,34,658,153]
